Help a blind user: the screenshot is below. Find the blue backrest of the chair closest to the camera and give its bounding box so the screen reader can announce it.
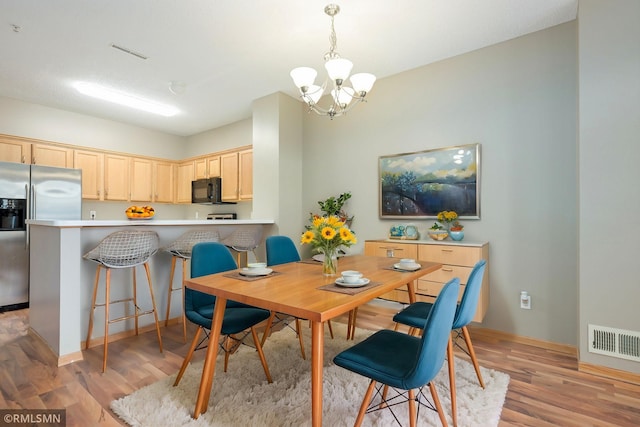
[403,277,460,390]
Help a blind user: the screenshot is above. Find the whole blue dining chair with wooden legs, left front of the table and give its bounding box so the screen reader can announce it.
[173,242,272,386]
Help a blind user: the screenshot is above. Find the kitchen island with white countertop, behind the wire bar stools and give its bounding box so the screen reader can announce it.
[27,219,274,366]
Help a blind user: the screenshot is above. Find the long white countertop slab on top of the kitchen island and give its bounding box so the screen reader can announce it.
[27,218,275,228]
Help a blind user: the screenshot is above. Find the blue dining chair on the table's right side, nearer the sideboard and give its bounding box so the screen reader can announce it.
[393,260,487,426]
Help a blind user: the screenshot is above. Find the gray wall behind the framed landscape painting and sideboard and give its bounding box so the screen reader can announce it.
[303,22,578,345]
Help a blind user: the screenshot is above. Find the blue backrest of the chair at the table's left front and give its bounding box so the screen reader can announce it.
[184,242,238,312]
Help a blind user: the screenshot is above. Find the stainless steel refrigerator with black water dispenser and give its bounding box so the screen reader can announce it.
[0,162,82,312]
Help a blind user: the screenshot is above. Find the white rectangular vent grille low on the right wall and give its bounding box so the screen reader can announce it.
[589,325,640,362]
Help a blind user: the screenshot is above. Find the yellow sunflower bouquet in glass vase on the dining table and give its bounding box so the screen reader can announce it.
[300,215,357,275]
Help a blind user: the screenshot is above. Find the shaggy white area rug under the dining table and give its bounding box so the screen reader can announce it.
[111,323,509,427]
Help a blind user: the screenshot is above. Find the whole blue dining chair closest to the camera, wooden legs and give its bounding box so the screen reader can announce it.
[333,278,460,427]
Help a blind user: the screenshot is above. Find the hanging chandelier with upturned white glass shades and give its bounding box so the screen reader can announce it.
[290,4,376,120]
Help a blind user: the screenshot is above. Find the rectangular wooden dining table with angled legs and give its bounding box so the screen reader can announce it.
[185,255,442,427]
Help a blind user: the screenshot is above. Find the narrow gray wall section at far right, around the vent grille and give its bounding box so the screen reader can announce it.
[579,0,640,373]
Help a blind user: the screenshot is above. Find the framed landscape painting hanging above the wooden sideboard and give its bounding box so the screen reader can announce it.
[379,144,480,219]
